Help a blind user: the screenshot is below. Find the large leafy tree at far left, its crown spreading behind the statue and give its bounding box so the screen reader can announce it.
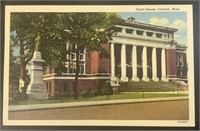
[10,13,66,90]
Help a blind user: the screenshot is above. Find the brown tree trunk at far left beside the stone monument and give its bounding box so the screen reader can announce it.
[19,40,26,94]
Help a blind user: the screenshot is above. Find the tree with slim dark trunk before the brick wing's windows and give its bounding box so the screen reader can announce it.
[65,13,121,99]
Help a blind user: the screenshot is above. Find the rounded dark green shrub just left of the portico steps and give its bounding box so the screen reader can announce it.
[101,81,113,95]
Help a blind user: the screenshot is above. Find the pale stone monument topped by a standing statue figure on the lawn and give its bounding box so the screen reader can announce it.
[27,33,48,99]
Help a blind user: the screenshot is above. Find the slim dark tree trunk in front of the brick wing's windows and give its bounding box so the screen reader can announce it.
[74,47,79,99]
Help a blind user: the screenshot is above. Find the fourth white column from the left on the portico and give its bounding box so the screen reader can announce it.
[142,47,149,81]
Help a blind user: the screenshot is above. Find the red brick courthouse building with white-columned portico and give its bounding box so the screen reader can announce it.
[44,17,187,96]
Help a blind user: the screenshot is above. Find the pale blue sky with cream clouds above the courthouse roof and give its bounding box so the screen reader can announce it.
[118,12,187,44]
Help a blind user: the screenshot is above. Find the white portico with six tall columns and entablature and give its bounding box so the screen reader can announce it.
[110,17,177,82]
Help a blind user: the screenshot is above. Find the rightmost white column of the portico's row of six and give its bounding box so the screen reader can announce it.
[161,49,168,81]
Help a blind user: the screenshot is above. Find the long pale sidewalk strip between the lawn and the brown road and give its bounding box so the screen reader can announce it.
[9,96,188,111]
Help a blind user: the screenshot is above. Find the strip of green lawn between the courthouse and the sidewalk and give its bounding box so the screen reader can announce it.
[10,91,188,105]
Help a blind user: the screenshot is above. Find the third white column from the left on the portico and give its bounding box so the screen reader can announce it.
[132,45,139,81]
